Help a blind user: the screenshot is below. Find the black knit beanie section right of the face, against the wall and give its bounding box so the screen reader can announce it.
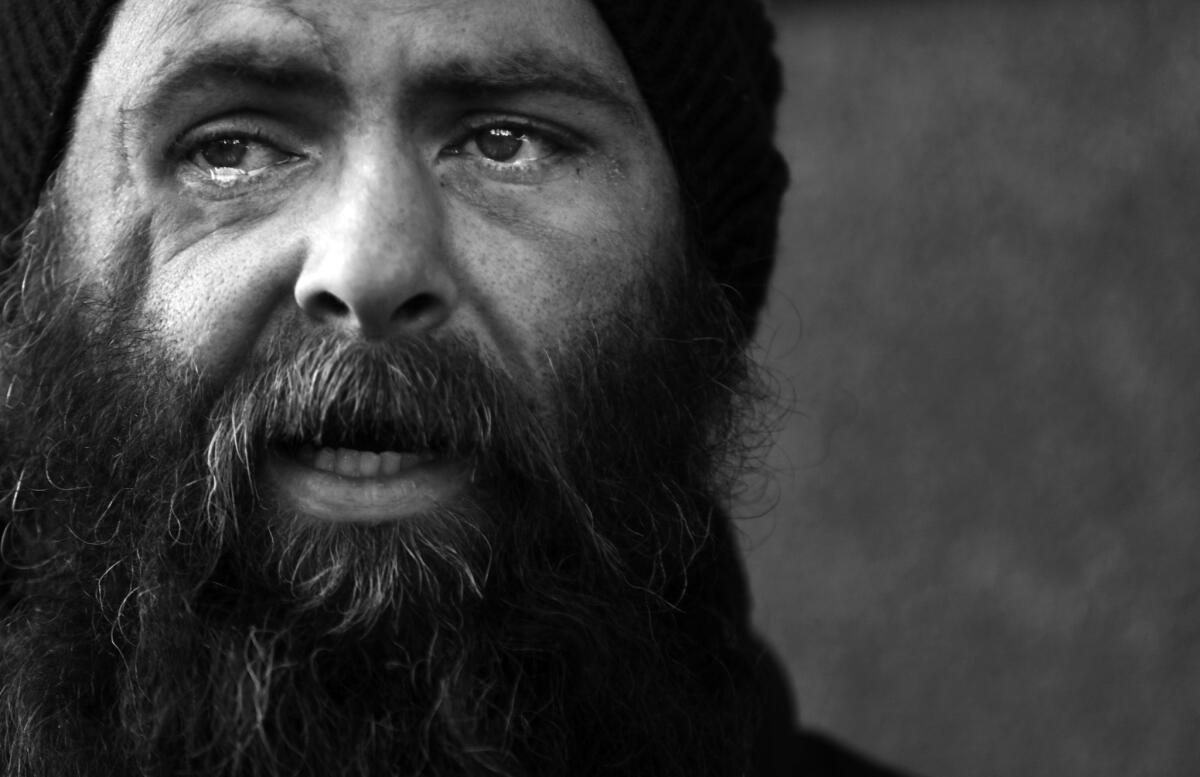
[594,0,787,333]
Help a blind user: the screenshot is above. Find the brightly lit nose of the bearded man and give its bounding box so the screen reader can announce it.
[295,141,458,339]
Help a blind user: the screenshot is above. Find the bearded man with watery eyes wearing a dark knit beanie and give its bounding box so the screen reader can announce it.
[0,0,912,775]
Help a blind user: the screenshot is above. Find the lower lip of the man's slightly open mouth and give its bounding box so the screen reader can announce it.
[265,451,468,524]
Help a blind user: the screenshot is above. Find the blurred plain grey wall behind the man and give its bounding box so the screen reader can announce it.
[742,0,1200,777]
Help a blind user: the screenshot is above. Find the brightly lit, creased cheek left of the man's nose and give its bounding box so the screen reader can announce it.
[64,163,300,377]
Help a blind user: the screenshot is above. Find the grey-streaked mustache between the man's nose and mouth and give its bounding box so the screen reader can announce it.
[205,332,557,518]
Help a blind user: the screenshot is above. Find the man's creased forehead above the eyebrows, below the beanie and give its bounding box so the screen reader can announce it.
[90,0,637,107]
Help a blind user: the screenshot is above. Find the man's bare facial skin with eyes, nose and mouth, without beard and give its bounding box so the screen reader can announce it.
[62,0,682,522]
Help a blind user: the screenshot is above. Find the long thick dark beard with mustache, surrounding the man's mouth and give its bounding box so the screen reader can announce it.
[0,193,754,776]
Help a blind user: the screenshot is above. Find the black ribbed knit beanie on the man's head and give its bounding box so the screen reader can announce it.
[0,0,787,335]
